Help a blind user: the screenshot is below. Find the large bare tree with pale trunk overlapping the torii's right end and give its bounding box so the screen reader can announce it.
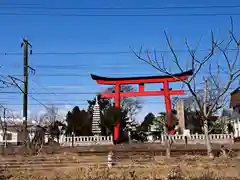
[133,19,240,156]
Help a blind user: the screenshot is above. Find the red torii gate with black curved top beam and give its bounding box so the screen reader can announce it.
[91,70,193,141]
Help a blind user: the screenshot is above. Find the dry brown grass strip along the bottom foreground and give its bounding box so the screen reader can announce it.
[0,156,240,180]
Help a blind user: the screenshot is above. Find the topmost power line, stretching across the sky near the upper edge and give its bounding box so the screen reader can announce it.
[0,4,240,10]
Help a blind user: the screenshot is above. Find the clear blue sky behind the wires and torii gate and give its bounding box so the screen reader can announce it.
[0,0,240,120]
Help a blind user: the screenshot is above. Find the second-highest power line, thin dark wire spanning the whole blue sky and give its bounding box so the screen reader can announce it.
[0,12,240,17]
